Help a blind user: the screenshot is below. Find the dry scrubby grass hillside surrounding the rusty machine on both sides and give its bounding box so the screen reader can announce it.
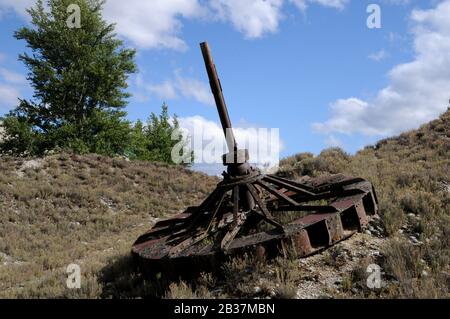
[0,111,450,298]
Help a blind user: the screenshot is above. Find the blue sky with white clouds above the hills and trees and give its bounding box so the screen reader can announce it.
[0,0,450,172]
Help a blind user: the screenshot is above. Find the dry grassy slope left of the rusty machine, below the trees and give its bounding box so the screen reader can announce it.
[0,154,217,298]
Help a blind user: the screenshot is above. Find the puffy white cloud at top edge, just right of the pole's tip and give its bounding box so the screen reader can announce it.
[209,0,283,38]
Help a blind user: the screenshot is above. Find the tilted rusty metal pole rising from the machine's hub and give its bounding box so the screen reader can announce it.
[200,42,237,152]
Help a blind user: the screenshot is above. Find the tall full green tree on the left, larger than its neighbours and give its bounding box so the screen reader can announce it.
[0,0,136,154]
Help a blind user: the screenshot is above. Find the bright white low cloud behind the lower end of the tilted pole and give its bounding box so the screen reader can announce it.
[179,116,283,167]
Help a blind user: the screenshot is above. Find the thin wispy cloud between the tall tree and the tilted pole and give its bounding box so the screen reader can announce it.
[136,71,214,105]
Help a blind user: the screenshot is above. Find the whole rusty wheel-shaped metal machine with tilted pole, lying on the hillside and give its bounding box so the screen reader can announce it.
[132,43,378,276]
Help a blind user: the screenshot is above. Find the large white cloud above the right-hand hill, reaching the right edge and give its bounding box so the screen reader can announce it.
[313,0,450,136]
